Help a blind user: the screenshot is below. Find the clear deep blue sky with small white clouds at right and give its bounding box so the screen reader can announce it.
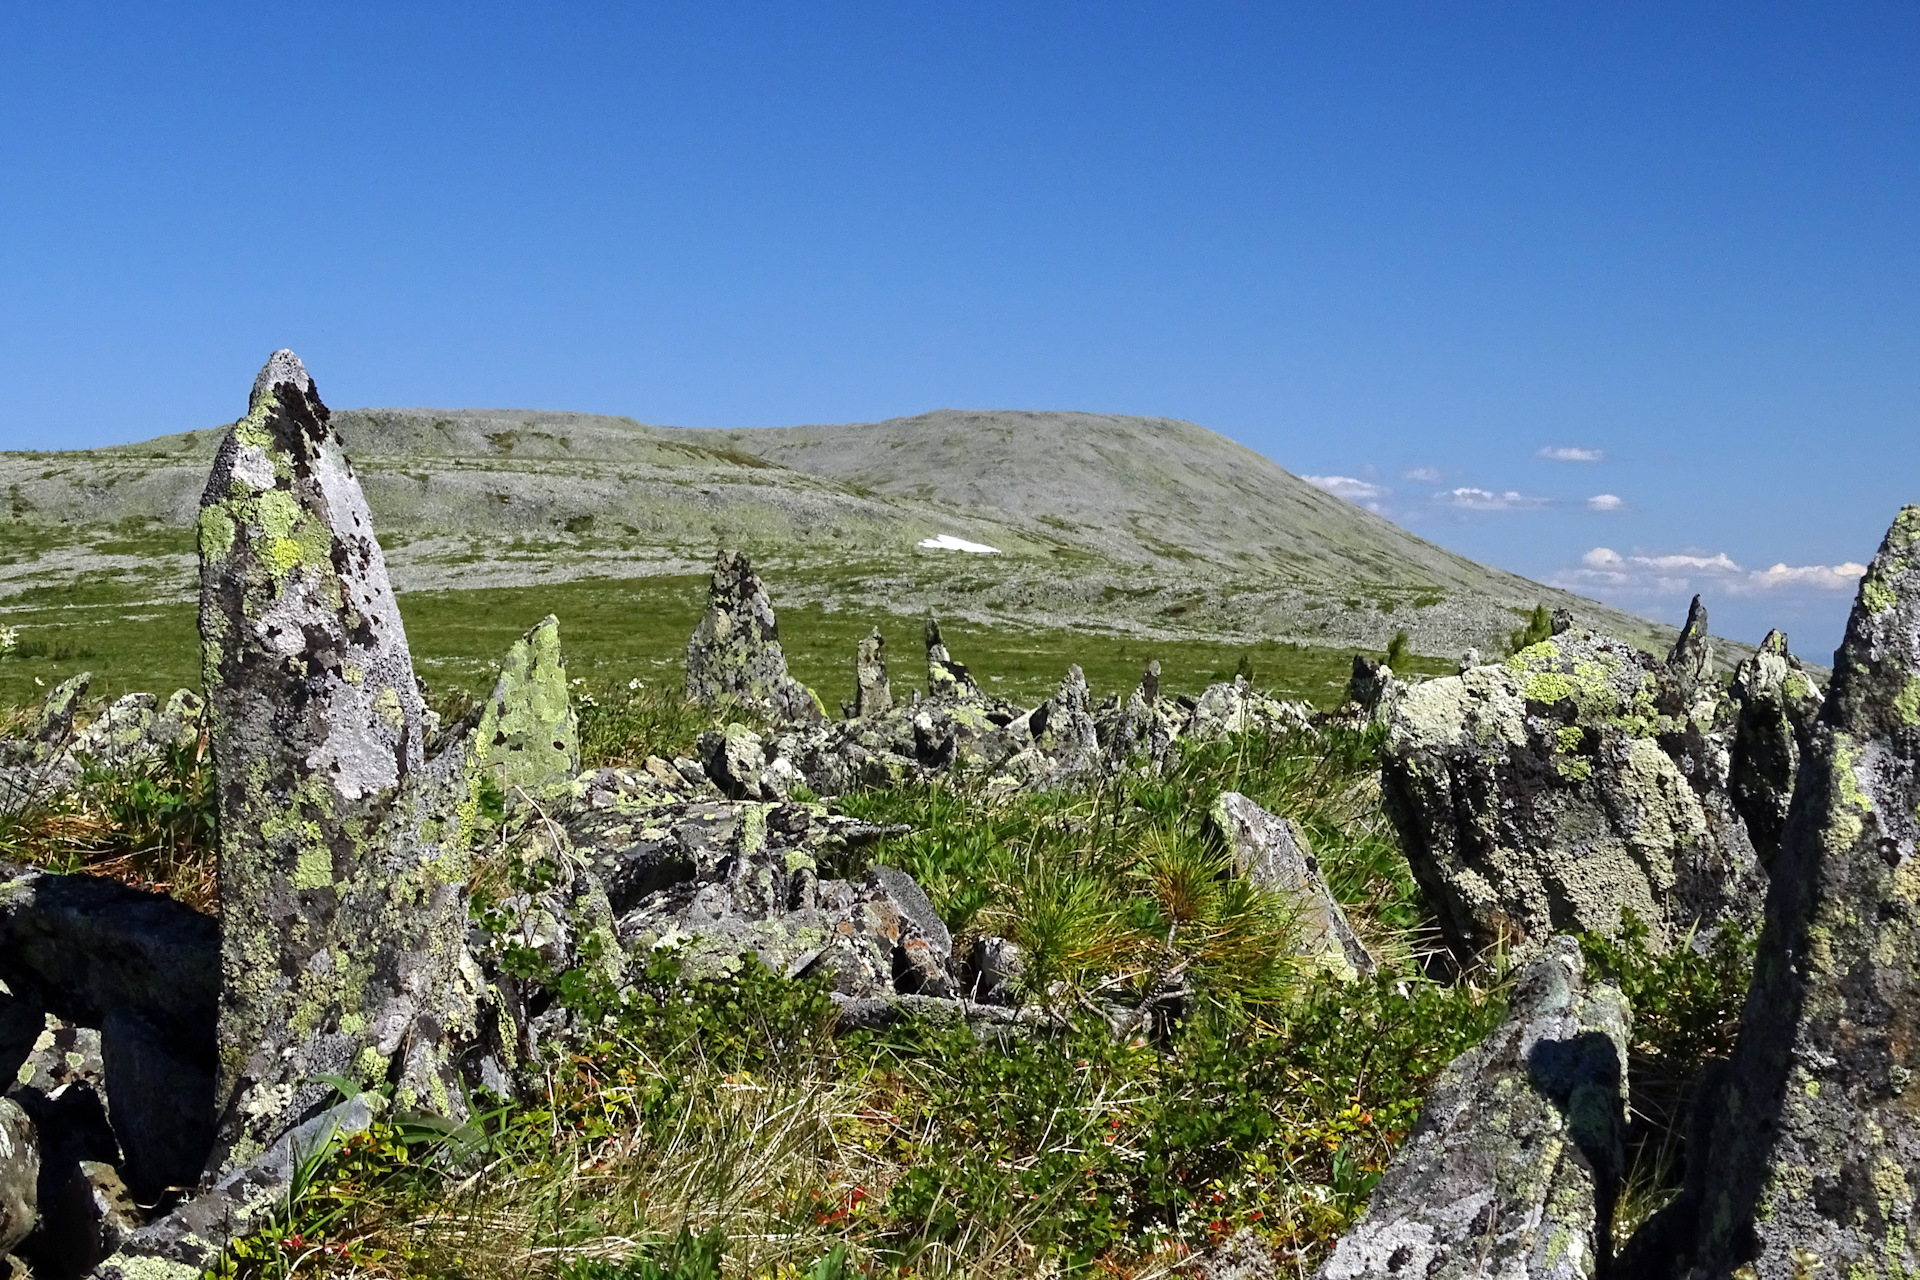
[0,0,1920,658]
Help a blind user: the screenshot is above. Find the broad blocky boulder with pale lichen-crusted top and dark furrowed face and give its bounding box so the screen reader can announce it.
[1382,631,1764,960]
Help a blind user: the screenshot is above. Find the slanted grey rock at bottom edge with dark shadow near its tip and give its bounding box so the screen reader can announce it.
[1319,936,1630,1280]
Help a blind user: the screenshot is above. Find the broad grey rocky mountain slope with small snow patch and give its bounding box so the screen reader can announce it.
[0,409,1697,656]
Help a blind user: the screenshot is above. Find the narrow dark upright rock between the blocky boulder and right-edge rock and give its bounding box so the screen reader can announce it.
[1728,631,1822,867]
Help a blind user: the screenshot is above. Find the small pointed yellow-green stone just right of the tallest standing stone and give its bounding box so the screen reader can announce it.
[474,614,580,802]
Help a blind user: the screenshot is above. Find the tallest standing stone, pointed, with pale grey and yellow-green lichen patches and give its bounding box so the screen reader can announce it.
[200,351,474,1173]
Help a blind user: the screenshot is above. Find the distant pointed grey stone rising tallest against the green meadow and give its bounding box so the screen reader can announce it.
[687,551,826,723]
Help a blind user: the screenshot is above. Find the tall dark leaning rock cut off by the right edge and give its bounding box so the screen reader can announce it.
[1688,507,1920,1280]
